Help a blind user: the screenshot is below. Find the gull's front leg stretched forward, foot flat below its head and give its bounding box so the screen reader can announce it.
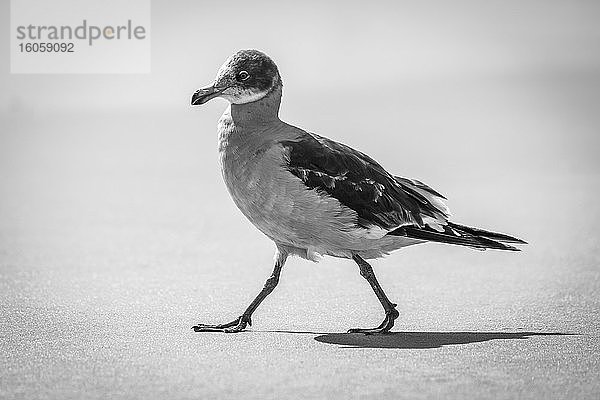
[192,249,288,333]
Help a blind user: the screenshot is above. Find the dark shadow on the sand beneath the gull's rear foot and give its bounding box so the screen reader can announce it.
[315,332,573,349]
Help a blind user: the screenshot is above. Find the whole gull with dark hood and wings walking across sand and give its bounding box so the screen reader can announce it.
[191,50,525,334]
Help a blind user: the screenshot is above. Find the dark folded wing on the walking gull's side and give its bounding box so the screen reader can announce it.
[281,133,447,230]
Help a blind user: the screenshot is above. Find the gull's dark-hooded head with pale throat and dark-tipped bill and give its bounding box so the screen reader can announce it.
[192,50,281,106]
